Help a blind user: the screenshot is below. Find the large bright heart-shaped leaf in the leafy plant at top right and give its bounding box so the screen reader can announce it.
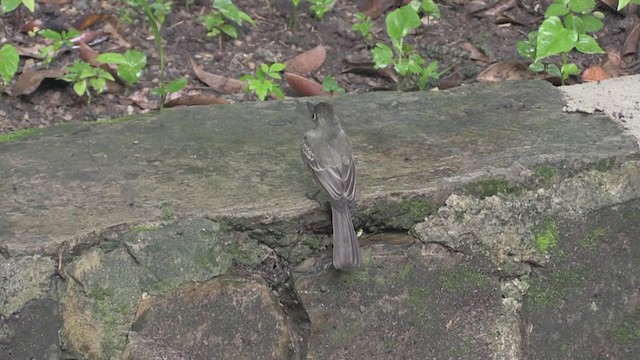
[535,16,578,62]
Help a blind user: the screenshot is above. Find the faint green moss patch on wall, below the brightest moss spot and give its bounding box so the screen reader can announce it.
[525,266,591,310]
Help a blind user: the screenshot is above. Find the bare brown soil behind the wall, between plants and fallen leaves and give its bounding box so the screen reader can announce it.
[0,0,638,133]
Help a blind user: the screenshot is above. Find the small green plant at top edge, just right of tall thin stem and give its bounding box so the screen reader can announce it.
[199,0,255,39]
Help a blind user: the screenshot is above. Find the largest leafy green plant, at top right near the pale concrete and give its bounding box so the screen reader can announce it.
[517,0,604,83]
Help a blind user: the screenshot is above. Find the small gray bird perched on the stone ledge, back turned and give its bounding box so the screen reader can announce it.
[301,102,362,270]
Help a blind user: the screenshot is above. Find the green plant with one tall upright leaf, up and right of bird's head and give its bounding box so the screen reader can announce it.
[371,0,440,90]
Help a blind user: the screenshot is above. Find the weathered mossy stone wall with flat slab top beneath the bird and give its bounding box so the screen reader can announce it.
[0,82,640,360]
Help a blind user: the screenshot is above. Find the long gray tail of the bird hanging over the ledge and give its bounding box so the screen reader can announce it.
[331,208,362,270]
